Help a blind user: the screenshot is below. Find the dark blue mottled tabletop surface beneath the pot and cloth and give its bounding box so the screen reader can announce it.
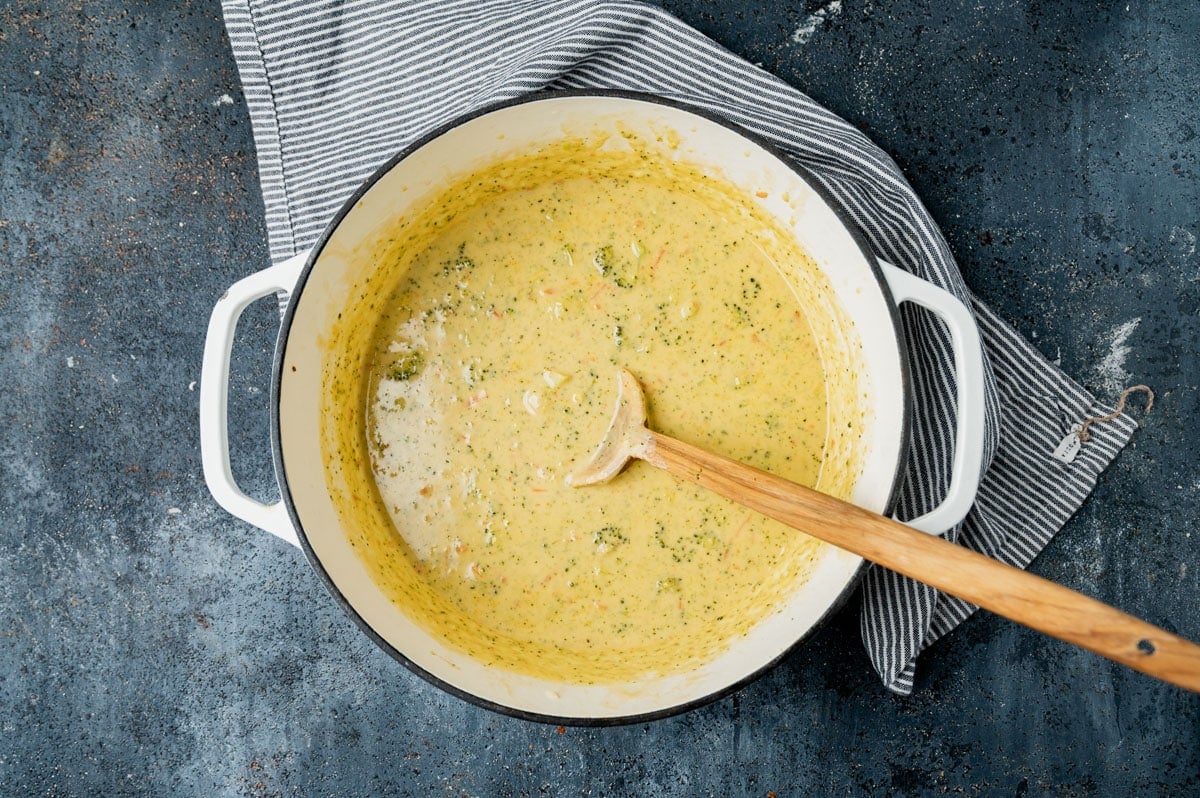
[0,0,1200,796]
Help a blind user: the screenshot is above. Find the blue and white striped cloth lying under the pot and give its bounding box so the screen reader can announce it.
[223,0,1134,694]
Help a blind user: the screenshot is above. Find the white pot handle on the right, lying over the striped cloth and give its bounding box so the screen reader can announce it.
[880,260,985,535]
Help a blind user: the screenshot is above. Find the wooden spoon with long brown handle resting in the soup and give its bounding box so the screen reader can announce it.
[566,370,1200,692]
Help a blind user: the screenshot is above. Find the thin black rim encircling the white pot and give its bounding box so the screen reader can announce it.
[270,89,912,727]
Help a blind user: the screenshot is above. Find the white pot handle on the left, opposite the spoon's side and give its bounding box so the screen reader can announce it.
[200,252,308,546]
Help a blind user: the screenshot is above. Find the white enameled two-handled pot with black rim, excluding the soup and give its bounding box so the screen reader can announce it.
[200,92,984,724]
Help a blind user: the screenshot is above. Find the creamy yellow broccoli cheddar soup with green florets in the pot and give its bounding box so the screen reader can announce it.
[323,137,859,684]
